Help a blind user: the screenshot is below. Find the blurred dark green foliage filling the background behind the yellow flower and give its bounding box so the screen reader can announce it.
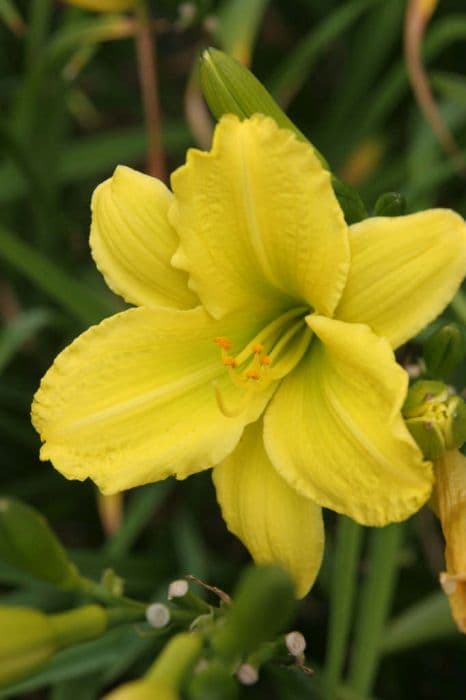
[0,0,466,700]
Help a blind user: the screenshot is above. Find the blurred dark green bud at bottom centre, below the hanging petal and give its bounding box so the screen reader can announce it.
[211,565,295,660]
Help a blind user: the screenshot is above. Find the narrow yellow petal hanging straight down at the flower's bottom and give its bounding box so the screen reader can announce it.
[213,421,324,598]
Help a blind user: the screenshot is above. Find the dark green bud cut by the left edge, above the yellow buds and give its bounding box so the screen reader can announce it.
[0,498,79,588]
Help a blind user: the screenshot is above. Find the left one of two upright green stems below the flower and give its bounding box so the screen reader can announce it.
[322,516,363,700]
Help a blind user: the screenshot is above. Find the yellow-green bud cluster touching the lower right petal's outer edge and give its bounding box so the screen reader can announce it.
[403,381,466,459]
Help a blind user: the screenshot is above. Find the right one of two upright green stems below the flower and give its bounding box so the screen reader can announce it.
[347,524,403,695]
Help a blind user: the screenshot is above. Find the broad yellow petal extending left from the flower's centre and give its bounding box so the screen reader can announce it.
[32,307,273,493]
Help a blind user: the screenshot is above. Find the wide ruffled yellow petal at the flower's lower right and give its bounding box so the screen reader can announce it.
[265,315,432,525]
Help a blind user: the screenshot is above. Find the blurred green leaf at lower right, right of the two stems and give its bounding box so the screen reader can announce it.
[380,592,458,654]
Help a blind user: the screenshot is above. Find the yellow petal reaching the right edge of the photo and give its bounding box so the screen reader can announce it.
[336,209,466,348]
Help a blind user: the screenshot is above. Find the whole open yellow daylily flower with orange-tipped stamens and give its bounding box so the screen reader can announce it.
[32,115,466,595]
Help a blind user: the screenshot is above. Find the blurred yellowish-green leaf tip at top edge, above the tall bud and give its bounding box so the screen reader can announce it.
[215,0,269,65]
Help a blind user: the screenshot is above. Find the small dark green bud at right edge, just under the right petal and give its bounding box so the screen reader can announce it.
[424,323,466,378]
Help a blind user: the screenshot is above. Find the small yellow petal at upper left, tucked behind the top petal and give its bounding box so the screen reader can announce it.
[90,165,199,309]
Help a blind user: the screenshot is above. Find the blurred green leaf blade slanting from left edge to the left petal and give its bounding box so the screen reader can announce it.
[0,225,114,326]
